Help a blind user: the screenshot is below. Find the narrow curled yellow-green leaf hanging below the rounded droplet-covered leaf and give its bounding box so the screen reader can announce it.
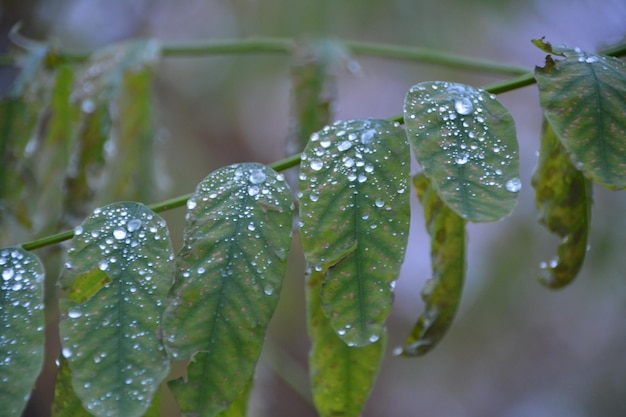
[401,174,467,356]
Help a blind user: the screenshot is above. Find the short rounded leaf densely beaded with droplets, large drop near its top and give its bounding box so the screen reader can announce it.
[404,81,521,222]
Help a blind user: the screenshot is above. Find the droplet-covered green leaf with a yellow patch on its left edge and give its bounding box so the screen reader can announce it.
[60,202,174,417]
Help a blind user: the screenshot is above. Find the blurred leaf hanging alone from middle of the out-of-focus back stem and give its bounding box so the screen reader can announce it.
[287,39,348,155]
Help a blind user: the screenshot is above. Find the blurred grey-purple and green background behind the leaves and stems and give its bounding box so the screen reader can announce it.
[0,0,626,417]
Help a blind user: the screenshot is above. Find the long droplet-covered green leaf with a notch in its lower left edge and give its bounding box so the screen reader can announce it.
[163,163,293,416]
